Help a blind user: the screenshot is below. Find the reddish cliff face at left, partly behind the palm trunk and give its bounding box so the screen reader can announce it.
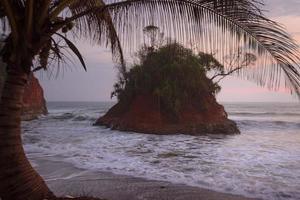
[0,70,48,120]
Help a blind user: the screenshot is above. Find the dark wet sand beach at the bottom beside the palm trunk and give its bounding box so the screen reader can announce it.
[30,158,254,200]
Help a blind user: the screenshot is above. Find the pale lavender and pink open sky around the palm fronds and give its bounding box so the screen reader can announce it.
[36,0,300,102]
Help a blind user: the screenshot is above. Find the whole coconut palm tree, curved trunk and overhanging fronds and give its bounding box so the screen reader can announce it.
[0,0,300,200]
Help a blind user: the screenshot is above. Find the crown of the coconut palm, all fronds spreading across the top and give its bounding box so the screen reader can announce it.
[0,0,300,95]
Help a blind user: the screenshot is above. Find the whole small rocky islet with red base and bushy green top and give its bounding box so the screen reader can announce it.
[95,43,239,135]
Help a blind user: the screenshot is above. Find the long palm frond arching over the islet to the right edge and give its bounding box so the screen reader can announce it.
[101,0,300,95]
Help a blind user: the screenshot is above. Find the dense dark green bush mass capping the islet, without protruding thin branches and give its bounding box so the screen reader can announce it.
[112,43,223,116]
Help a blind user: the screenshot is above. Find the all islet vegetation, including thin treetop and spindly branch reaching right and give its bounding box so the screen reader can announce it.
[111,25,256,119]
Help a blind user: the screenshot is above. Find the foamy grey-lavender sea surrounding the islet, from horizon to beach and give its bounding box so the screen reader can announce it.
[22,102,300,200]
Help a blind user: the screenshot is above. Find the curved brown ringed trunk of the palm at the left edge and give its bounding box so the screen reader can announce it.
[0,70,52,200]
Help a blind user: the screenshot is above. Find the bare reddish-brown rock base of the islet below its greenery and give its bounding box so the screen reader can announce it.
[95,94,239,135]
